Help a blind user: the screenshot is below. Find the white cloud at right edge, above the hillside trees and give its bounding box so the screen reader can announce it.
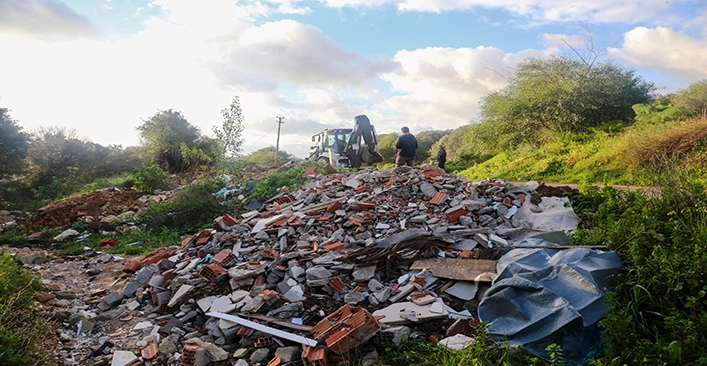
[609,27,707,83]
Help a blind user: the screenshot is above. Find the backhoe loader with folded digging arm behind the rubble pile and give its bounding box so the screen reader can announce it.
[309,115,383,168]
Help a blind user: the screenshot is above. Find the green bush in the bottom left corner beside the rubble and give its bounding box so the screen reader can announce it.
[0,252,50,365]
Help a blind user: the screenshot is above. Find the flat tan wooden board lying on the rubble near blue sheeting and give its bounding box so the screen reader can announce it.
[410,258,496,282]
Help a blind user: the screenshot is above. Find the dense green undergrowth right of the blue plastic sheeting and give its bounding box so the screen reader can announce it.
[574,172,707,365]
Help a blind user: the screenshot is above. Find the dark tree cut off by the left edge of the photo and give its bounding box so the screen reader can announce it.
[0,108,29,179]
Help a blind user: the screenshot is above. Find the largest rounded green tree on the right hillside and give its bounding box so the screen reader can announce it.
[477,56,656,148]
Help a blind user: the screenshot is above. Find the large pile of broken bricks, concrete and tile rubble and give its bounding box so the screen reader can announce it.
[17,167,584,366]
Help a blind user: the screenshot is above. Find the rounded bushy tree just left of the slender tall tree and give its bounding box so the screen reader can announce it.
[136,109,217,174]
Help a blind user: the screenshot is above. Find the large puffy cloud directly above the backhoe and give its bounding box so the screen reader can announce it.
[208,20,395,91]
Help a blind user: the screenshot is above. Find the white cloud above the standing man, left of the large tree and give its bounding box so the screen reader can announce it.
[384,47,549,131]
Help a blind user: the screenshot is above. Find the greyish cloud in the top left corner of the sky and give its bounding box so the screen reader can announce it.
[0,0,99,41]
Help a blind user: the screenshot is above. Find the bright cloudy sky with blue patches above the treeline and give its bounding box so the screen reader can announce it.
[0,0,707,157]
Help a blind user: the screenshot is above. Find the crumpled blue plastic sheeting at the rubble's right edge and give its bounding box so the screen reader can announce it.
[479,239,621,365]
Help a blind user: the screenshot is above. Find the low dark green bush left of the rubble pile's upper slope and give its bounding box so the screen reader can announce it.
[138,181,224,234]
